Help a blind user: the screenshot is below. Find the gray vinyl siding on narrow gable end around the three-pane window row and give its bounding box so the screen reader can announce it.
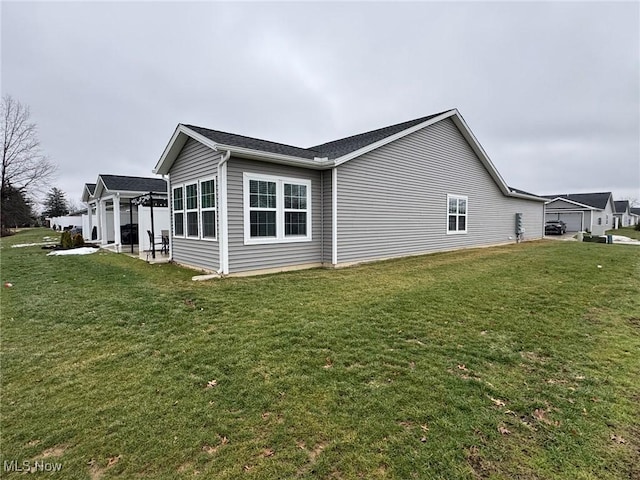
[169,139,220,272]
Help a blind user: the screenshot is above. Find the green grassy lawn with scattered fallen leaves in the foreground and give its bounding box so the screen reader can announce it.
[0,230,640,479]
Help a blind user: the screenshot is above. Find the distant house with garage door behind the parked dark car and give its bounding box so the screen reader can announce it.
[544,192,615,235]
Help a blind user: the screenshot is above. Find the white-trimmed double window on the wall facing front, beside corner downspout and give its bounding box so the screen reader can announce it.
[244,172,311,244]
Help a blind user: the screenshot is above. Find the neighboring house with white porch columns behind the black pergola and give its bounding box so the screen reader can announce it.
[82,174,170,251]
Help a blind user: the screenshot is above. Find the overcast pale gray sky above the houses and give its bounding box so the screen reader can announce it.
[0,1,640,204]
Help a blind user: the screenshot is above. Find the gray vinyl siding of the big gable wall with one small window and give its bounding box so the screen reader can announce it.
[338,119,544,263]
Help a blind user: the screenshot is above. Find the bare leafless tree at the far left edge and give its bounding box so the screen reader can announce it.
[0,95,56,233]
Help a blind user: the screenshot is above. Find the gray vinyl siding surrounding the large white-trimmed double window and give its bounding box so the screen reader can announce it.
[227,157,322,273]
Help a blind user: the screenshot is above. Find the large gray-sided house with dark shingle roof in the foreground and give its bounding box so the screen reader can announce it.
[154,109,545,274]
